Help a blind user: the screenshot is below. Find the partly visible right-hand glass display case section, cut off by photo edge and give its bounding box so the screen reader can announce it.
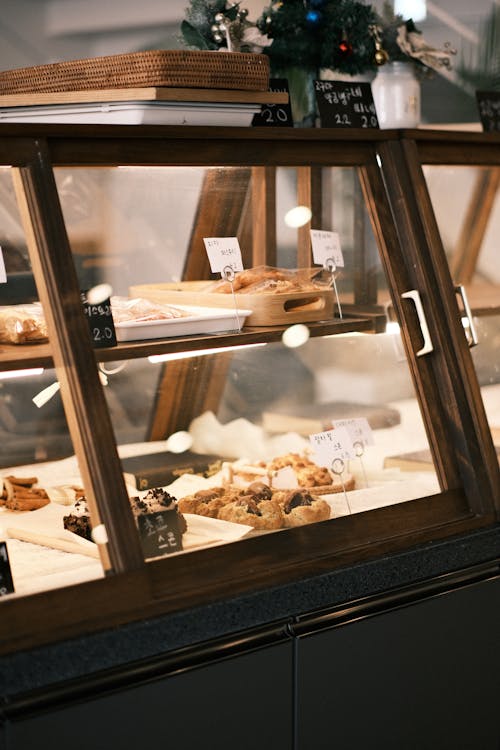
[402,133,500,452]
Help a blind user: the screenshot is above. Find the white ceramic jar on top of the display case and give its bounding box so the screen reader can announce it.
[372,62,420,128]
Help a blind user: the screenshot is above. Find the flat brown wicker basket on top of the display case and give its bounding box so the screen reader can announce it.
[0,50,269,94]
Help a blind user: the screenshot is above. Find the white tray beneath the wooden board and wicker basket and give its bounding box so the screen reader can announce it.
[0,101,261,127]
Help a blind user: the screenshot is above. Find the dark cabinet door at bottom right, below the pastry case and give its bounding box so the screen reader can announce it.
[297,578,500,750]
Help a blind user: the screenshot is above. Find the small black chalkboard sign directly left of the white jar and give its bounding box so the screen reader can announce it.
[314,81,379,128]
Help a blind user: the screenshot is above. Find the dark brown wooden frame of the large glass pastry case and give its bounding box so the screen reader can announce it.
[0,125,500,653]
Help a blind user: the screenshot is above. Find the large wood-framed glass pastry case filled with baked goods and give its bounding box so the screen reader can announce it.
[0,125,498,649]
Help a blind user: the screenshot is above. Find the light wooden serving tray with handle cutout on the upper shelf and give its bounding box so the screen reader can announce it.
[129,281,334,326]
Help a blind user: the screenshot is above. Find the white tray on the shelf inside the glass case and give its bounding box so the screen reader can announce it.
[115,305,252,341]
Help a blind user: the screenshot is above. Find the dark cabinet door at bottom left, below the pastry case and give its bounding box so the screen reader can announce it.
[6,642,292,750]
